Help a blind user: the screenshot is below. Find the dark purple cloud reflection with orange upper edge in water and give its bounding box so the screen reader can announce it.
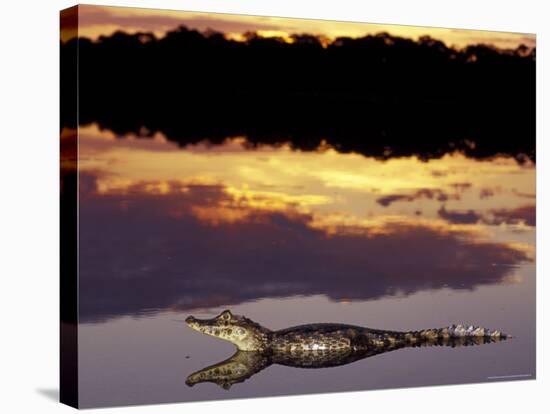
[80,173,531,322]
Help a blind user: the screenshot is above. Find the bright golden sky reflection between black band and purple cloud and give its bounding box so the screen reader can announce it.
[75,126,535,251]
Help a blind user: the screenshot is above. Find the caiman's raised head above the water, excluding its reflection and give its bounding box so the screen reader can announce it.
[185,310,270,351]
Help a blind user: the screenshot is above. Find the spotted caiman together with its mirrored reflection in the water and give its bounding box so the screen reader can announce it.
[186,310,510,389]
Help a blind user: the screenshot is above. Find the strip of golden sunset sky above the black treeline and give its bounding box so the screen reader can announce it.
[62,5,536,48]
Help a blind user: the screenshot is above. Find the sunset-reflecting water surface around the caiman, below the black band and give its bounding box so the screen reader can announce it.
[75,125,536,406]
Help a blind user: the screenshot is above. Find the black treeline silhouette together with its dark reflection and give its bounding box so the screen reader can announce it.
[61,26,535,162]
